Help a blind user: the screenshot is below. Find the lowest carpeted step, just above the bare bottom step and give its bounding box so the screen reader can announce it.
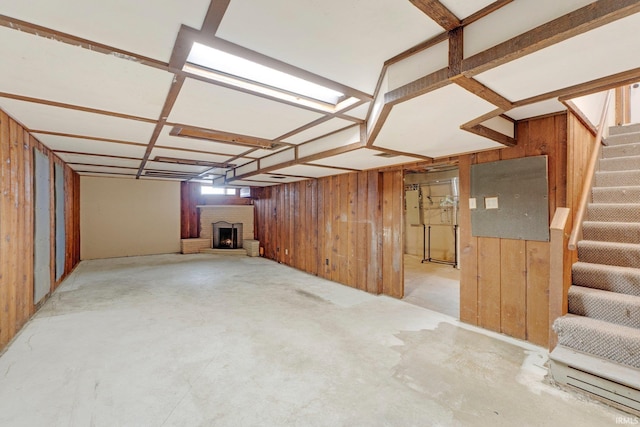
[553,314,640,368]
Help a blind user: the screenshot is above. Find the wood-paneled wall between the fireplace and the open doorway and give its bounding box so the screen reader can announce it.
[254,171,404,298]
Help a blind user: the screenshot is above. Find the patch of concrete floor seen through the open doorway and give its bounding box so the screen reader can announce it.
[403,254,460,319]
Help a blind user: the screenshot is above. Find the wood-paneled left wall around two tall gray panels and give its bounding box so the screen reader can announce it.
[0,111,80,350]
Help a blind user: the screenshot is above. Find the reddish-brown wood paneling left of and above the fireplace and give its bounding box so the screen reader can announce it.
[180,181,255,239]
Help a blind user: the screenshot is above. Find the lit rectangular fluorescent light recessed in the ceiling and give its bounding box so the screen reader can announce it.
[184,43,359,112]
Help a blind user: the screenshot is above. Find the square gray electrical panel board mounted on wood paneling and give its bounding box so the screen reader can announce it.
[469,156,549,242]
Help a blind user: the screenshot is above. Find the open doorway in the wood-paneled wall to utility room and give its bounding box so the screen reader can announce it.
[403,164,460,318]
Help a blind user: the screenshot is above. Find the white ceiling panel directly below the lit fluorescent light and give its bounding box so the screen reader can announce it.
[168,79,322,139]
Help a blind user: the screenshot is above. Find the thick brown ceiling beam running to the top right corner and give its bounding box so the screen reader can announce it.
[462,0,640,77]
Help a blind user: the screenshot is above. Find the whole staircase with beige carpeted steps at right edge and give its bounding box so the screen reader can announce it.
[550,124,640,415]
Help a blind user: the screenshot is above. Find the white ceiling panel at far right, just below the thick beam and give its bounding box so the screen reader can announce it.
[476,13,640,100]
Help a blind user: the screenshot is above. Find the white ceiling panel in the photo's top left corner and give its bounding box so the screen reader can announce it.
[0,0,210,62]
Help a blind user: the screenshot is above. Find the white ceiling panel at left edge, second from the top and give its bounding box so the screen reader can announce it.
[0,27,173,120]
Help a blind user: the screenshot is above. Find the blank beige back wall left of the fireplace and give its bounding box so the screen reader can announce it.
[80,176,180,260]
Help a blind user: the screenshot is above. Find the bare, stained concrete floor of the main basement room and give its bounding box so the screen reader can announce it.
[0,255,621,427]
